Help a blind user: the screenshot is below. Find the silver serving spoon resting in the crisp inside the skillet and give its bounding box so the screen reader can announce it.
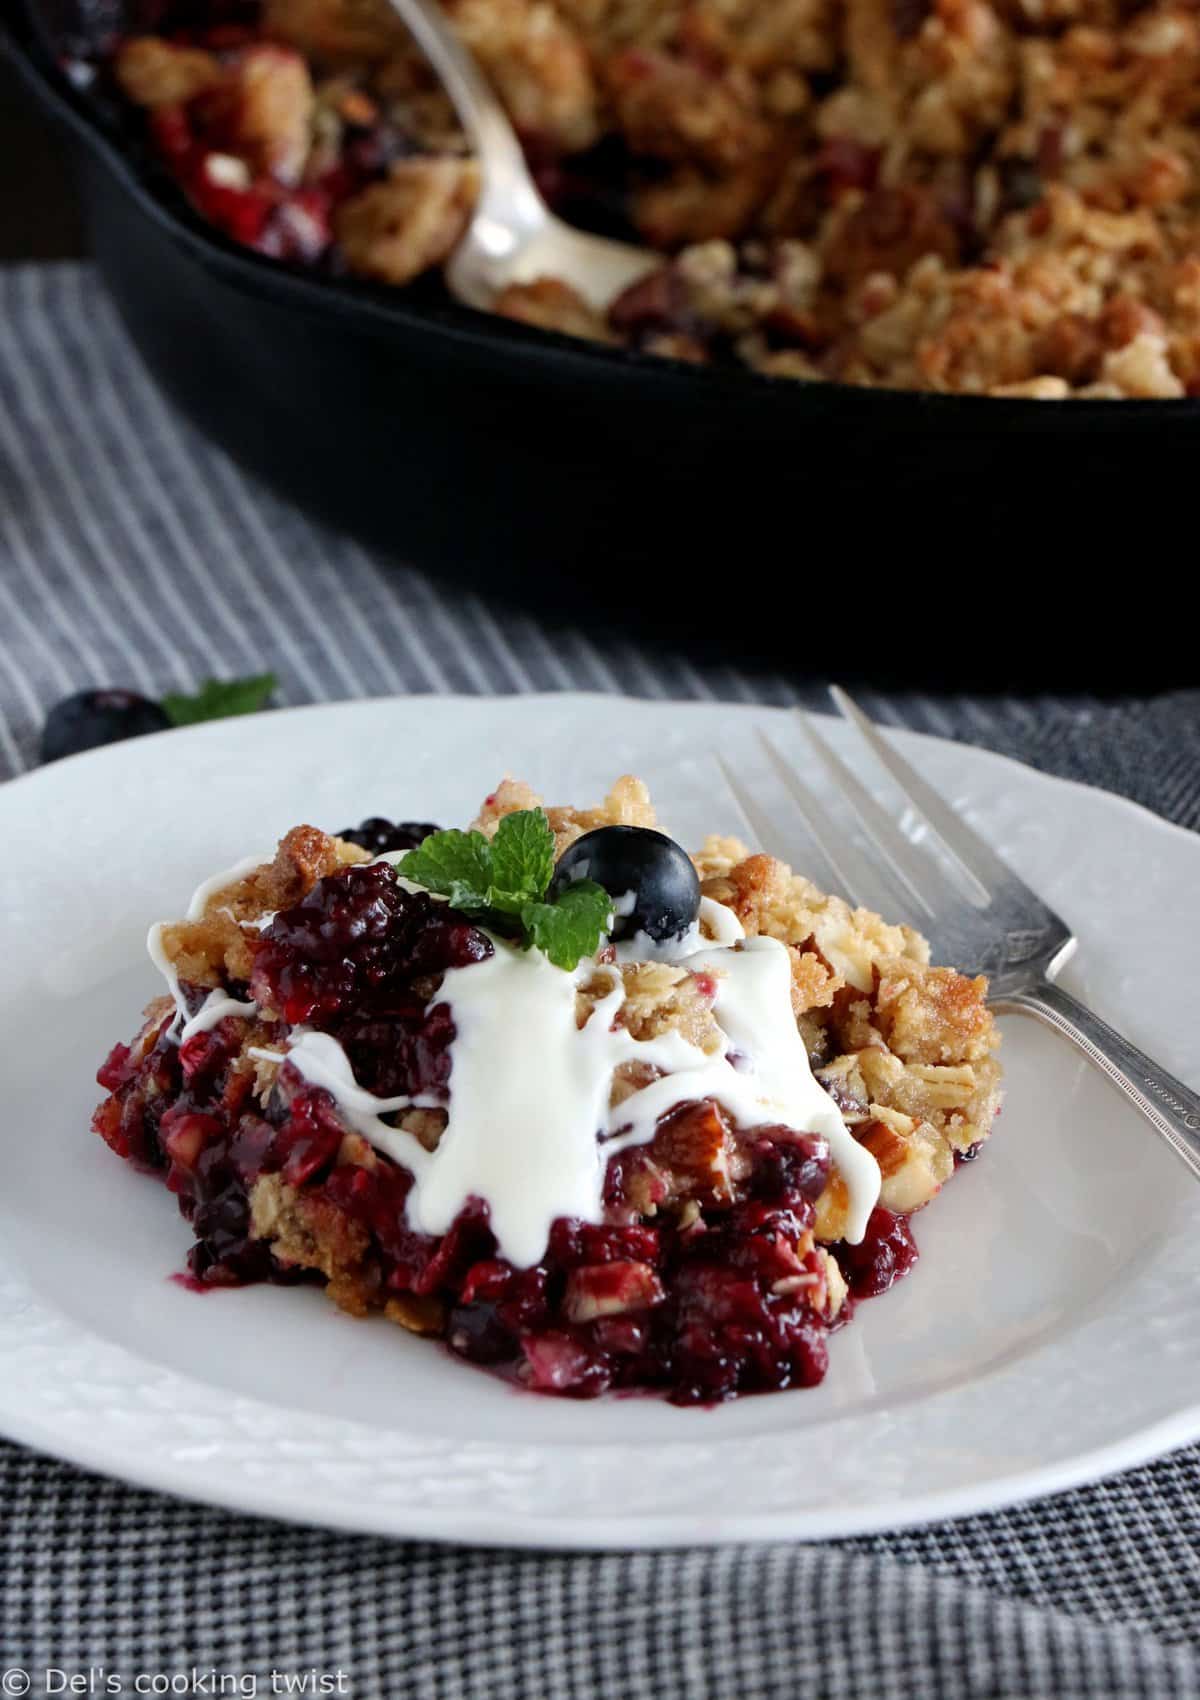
[389,0,663,311]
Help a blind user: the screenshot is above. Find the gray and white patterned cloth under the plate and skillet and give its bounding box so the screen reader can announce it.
[0,267,1200,1700]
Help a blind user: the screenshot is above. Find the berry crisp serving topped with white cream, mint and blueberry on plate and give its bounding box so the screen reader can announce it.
[93,777,999,1404]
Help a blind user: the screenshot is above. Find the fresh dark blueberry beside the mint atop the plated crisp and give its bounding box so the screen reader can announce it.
[551,826,700,940]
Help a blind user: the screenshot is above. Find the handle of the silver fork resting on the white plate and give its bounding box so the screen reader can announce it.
[996,981,1200,1180]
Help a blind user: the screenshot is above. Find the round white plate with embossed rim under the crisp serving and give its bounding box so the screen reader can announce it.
[0,697,1200,1547]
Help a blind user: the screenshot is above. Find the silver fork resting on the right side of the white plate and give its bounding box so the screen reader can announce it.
[717,685,1200,1180]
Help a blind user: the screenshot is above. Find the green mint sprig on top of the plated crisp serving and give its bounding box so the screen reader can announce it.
[396,809,612,969]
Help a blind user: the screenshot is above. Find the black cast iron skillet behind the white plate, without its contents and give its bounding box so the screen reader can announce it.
[0,0,1200,676]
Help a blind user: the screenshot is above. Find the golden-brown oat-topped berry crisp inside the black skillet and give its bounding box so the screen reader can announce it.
[105,0,1200,400]
